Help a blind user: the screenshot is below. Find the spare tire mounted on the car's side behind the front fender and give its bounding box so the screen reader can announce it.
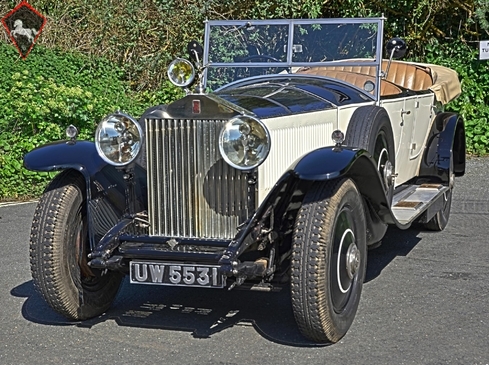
[344,105,396,203]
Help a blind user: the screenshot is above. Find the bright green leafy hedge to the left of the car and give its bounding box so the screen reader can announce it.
[0,43,181,200]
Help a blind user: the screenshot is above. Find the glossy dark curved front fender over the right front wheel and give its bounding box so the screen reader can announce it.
[221,147,396,264]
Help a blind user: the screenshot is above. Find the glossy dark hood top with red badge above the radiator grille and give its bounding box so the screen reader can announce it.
[142,75,371,120]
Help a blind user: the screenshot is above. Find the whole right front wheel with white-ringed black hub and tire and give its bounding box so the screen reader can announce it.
[291,179,367,343]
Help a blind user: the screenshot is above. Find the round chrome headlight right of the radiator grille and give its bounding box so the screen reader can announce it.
[219,115,270,170]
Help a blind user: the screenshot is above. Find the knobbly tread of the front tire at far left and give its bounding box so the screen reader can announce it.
[29,170,120,320]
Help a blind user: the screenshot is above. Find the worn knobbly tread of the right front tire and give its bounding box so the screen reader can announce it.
[291,180,364,342]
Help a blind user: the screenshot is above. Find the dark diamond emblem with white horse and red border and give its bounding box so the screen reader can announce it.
[2,0,46,59]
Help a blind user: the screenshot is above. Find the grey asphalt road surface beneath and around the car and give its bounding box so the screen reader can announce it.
[0,159,489,365]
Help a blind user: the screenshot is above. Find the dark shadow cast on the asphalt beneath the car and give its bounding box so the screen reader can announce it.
[11,223,420,347]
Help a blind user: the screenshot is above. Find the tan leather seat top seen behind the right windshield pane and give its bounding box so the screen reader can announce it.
[297,66,402,96]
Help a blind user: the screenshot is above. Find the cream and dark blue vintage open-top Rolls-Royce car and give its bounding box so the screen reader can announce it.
[24,18,465,342]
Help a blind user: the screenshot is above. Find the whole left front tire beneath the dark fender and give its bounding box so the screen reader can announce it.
[30,171,122,320]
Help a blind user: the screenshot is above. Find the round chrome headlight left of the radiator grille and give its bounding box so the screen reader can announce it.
[95,112,143,166]
